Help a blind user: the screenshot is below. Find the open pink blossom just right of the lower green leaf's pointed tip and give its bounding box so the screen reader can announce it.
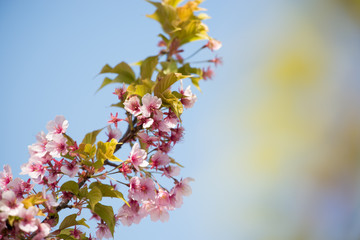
[129,177,156,201]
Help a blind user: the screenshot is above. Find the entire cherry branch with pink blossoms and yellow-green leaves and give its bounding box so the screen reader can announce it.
[0,0,222,240]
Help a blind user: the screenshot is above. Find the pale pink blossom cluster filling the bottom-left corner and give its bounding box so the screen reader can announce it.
[0,165,51,240]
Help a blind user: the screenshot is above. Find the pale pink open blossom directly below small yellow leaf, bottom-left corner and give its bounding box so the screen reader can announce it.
[18,206,40,233]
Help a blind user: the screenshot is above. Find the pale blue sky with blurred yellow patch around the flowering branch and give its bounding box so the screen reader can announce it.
[0,0,360,240]
